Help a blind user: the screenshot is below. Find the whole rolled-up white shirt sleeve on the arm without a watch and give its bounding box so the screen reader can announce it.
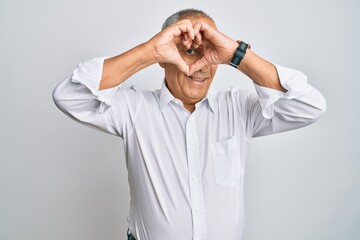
[53,57,138,137]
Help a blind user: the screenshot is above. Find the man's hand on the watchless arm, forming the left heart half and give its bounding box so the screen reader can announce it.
[148,19,201,75]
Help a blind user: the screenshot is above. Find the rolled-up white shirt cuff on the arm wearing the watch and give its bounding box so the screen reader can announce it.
[254,64,309,119]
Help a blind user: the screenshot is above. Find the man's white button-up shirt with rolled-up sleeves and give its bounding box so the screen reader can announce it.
[53,58,326,240]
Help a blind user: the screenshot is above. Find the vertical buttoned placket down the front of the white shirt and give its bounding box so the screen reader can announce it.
[186,113,206,240]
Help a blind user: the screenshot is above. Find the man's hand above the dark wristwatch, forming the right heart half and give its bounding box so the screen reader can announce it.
[189,22,238,74]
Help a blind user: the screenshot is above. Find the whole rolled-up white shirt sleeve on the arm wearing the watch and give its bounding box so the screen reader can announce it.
[245,65,326,137]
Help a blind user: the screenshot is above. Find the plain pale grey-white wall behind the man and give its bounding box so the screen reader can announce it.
[0,0,360,240]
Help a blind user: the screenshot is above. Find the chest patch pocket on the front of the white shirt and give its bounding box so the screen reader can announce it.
[210,136,242,186]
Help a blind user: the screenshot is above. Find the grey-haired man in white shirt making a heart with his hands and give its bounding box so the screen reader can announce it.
[53,9,326,240]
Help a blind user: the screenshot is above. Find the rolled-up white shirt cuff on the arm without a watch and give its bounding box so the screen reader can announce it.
[71,57,120,113]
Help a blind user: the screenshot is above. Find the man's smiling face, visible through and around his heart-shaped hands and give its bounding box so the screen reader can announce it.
[160,17,217,110]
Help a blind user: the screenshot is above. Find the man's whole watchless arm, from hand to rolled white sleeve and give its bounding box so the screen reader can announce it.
[53,20,199,136]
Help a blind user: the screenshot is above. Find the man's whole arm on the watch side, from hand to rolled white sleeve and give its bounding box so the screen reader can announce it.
[190,22,326,137]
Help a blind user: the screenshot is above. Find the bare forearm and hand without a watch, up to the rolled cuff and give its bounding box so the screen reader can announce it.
[99,19,199,90]
